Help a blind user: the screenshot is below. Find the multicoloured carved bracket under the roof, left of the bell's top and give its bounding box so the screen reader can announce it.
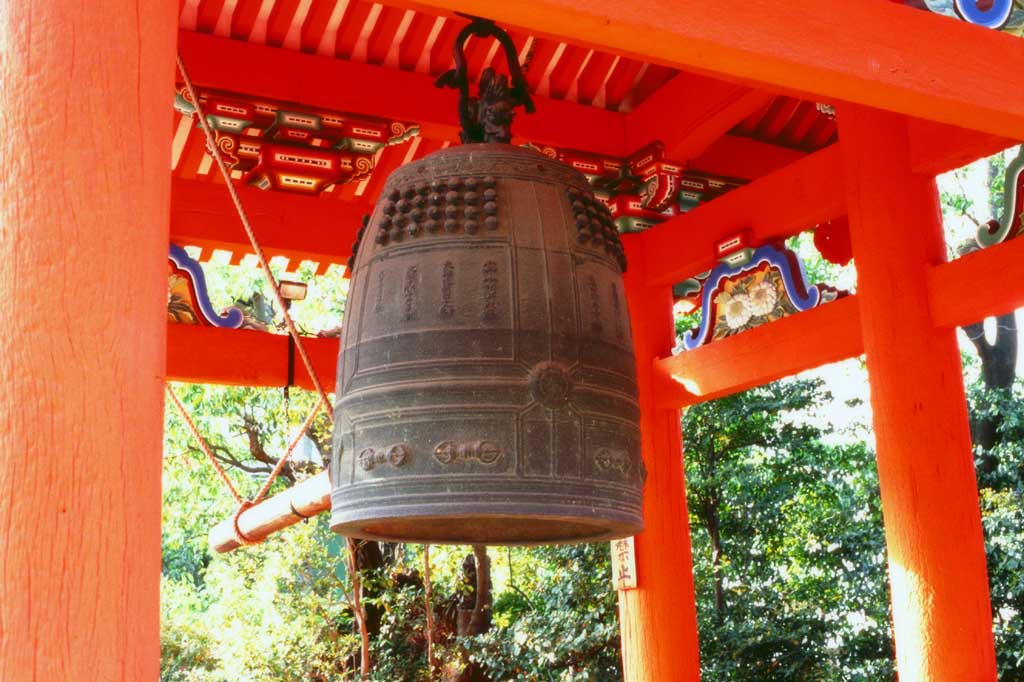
[174,89,419,195]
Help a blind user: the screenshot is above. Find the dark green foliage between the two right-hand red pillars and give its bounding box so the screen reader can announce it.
[683,380,892,681]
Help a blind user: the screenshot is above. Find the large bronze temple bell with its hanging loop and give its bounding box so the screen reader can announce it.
[331,19,645,545]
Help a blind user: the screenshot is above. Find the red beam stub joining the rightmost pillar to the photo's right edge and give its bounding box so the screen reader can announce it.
[928,238,1024,327]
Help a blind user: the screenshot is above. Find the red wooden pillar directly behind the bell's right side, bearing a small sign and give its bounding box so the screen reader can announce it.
[618,236,700,682]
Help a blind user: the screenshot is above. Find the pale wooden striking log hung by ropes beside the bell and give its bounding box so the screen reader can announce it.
[210,471,331,554]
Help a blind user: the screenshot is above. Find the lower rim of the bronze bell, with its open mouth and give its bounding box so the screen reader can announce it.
[331,504,643,546]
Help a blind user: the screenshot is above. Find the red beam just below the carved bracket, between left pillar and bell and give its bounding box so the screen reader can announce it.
[171,178,373,264]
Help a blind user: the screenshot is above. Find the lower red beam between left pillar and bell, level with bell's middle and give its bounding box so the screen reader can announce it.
[167,323,338,392]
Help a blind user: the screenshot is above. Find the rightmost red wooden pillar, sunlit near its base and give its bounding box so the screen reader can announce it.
[839,105,995,682]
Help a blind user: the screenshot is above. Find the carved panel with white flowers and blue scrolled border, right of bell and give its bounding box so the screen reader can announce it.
[676,240,846,350]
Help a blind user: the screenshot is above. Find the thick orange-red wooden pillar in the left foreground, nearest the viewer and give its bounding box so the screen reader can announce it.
[0,0,177,682]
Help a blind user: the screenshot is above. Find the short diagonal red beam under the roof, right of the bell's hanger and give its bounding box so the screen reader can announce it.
[626,72,772,163]
